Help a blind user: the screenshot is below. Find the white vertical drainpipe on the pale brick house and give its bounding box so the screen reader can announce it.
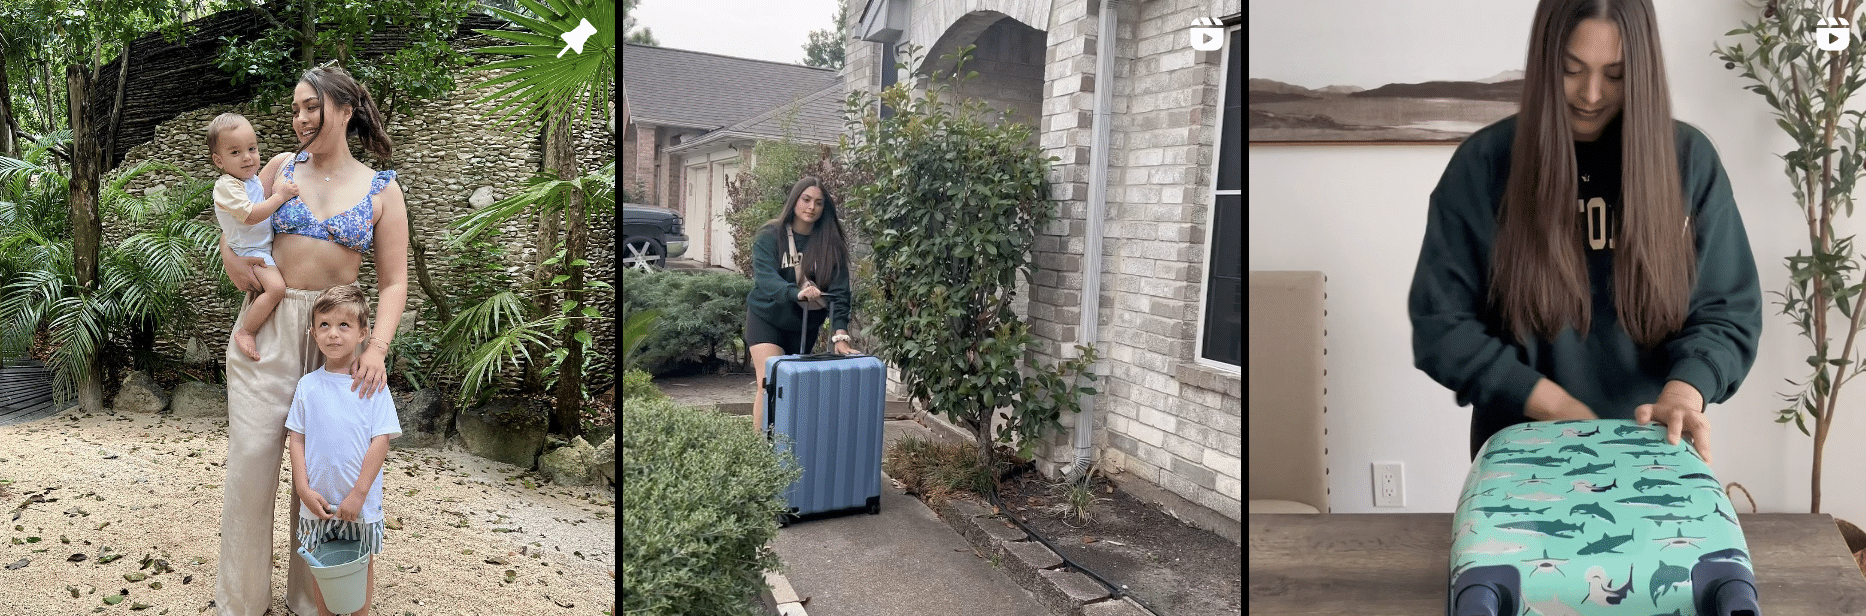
[1062,0,1118,478]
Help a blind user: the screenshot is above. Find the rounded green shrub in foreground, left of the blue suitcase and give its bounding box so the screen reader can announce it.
[621,399,799,616]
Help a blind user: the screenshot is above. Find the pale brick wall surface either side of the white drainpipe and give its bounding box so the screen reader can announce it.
[1030,0,1243,519]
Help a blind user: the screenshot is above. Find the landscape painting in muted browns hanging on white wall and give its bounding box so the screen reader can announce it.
[1248,0,1536,146]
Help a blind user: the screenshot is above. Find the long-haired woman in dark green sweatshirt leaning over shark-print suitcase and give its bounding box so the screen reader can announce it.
[1409,0,1762,461]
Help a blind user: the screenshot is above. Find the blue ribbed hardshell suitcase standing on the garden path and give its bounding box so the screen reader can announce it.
[765,355,888,523]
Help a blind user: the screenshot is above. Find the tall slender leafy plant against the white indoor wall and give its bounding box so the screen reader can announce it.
[1713,0,1866,513]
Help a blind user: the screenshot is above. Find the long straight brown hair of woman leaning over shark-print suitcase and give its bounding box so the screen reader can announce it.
[1489,0,1698,347]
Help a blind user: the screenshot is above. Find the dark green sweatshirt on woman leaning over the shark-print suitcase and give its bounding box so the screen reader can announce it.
[1407,116,1762,455]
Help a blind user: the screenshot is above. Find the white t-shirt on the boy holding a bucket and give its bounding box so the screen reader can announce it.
[285,368,401,523]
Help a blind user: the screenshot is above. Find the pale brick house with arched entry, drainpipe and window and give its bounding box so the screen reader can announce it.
[840,0,1245,539]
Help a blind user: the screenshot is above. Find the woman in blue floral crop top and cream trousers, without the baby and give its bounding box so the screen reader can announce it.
[215,67,409,616]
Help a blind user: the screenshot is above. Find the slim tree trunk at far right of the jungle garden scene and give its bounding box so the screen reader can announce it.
[550,114,590,439]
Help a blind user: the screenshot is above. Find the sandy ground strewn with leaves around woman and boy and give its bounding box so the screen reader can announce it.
[0,411,616,616]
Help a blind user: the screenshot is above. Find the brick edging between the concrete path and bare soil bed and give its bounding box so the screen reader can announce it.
[929,500,1149,616]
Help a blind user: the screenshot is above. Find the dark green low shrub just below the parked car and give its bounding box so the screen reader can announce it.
[621,271,752,375]
